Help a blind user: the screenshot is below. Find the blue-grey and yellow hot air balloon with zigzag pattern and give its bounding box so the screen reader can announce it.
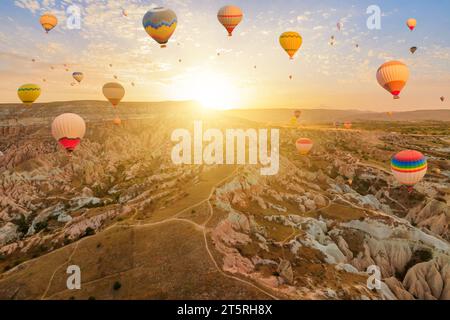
[142,7,178,48]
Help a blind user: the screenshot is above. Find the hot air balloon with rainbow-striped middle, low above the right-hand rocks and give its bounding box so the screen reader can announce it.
[391,150,428,191]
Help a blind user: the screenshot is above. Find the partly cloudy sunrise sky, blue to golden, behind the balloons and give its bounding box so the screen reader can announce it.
[0,0,450,111]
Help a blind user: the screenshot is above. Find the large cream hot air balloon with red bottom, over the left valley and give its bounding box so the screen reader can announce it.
[52,113,86,153]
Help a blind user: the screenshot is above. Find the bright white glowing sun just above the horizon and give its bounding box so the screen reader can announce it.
[191,73,239,110]
